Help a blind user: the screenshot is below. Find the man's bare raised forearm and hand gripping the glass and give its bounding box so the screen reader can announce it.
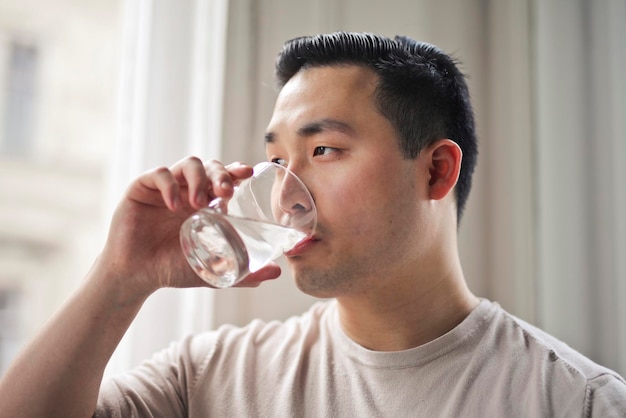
[0,158,280,417]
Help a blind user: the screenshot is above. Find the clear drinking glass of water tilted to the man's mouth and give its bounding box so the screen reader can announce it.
[180,162,317,288]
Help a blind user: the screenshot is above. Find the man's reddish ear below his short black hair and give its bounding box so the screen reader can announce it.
[425,139,463,200]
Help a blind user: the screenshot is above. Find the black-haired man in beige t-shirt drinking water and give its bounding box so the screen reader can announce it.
[0,33,626,417]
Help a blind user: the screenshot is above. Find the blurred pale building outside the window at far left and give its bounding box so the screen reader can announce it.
[0,0,121,374]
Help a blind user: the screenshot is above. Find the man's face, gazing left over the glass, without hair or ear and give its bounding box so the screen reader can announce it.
[266,66,427,297]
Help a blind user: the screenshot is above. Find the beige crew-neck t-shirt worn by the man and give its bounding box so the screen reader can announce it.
[95,300,626,418]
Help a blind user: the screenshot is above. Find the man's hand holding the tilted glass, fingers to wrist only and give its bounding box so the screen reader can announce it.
[96,157,280,297]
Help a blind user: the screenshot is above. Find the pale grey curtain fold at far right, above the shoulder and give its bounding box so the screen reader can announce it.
[533,0,626,374]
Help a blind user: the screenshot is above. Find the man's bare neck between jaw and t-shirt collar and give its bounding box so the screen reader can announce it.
[337,267,478,351]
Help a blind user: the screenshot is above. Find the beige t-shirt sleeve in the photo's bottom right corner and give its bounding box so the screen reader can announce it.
[585,374,626,418]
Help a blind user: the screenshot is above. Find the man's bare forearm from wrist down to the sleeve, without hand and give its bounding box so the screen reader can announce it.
[0,262,145,417]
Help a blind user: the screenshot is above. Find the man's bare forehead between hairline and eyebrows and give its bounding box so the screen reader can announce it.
[268,65,378,131]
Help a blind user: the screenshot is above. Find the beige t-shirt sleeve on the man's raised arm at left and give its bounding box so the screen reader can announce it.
[93,334,214,418]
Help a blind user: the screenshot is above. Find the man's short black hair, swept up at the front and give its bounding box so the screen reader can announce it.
[275,32,478,221]
